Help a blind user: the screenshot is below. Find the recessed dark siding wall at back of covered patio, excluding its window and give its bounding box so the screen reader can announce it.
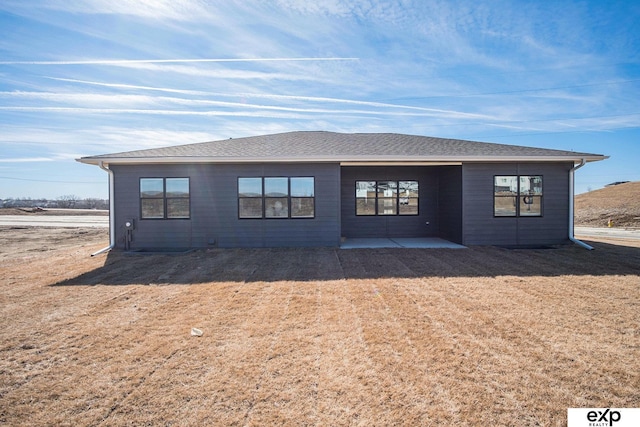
[341,166,438,237]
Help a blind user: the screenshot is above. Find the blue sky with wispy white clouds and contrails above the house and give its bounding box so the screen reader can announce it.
[0,0,640,199]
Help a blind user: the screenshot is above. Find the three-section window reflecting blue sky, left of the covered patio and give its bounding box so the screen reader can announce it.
[238,177,315,218]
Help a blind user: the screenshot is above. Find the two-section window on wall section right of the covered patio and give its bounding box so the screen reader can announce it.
[493,175,542,217]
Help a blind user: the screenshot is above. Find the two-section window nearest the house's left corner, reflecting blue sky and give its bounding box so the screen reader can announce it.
[140,178,191,219]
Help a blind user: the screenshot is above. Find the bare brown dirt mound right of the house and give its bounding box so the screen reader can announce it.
[575,181,640,228]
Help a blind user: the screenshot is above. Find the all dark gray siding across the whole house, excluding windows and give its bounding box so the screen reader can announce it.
[107,162,573,249]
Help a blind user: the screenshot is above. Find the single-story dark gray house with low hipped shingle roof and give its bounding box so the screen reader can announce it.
[78,132,607,249]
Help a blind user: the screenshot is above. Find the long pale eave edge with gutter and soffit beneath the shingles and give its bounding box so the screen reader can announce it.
[76,155,609,166]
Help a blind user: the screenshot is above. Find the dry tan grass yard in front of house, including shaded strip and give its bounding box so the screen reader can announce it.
[0,227,640,426]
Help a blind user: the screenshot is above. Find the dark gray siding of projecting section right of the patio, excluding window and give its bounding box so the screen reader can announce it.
[462,163,573,246]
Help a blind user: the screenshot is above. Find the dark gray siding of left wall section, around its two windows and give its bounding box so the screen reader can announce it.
[112,164,340,249]
